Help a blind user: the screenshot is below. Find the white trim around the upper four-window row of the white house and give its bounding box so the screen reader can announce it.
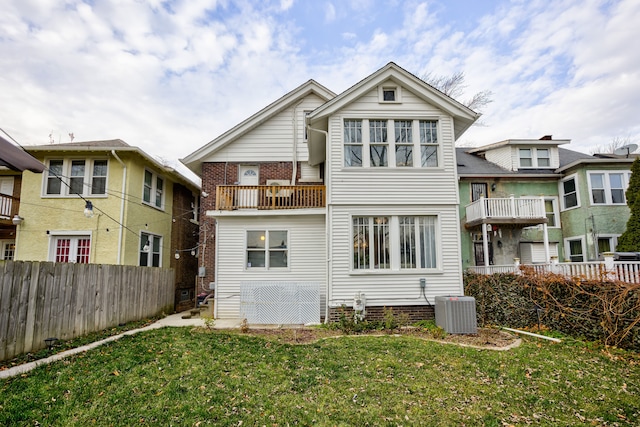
[340,118,443,171]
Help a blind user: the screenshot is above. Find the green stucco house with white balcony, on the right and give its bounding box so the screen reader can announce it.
[457,136,633,268]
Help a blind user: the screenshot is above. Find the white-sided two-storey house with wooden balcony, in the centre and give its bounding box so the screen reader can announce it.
[182,63,479,323]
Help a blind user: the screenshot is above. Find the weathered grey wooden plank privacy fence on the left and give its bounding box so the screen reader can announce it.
[0,261,175,360]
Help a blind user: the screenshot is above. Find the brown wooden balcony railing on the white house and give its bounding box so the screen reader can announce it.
[216,185,326,210]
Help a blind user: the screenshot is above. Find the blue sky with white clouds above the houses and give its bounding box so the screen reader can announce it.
[0,0,640,179]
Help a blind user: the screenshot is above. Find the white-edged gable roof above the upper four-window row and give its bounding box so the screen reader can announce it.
[309,62,480,139]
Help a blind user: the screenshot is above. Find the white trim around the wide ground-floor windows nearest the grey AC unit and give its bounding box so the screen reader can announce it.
[349,213,442,276]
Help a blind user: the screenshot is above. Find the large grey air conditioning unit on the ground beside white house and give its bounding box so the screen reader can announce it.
[435,296,478,334]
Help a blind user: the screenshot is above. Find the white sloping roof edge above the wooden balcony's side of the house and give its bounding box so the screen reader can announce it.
[180,80,336,175]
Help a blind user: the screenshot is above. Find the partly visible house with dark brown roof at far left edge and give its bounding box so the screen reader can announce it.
[0,137,44,261]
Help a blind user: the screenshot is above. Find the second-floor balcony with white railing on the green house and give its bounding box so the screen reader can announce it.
[465,196,548,227]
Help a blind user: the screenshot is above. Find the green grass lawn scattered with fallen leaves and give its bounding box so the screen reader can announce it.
[0,328,640,426]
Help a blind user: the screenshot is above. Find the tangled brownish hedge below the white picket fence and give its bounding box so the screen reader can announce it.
[464,269,640,351]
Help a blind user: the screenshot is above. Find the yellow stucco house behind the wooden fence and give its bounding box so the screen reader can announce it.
[15,139,200,308]
